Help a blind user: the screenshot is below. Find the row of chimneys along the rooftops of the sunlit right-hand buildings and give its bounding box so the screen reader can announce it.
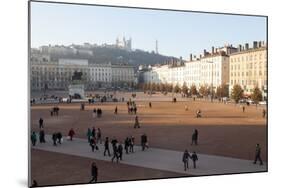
[189,41,265,61]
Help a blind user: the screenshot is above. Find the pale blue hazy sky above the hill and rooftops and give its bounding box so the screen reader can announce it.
[31,2,266,59]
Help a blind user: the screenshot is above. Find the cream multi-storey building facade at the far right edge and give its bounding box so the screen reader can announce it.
[229,41,267,99]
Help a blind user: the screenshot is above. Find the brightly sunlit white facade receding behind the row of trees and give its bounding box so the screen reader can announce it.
[143,52,229,88]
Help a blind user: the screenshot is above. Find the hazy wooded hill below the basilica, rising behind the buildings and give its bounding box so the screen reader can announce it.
[47,46,177,66]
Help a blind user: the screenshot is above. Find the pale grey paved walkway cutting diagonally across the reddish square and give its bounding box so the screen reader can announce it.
[32,135,267,175]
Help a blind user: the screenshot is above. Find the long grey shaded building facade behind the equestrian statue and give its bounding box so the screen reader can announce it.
[30,56,135,90]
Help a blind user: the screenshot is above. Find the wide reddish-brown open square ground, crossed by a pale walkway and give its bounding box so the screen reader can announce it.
[31,92,267,185]
